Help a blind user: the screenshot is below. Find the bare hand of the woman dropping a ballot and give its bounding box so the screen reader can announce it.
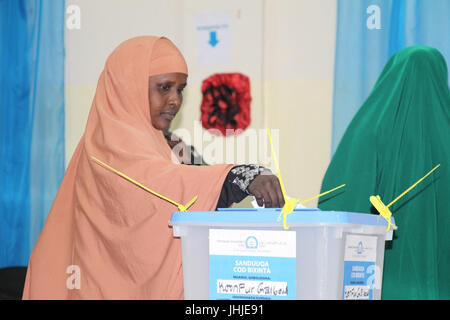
[247,173,284,208]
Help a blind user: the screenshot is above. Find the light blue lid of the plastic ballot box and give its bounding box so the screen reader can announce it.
[169,208,395,227]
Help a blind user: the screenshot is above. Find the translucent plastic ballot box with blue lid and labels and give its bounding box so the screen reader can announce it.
[169,208,395,300]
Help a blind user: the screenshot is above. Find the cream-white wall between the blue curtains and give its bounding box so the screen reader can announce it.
[66,0,336,207]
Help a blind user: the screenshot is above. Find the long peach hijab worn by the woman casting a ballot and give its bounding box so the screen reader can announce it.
[23,36,232,299]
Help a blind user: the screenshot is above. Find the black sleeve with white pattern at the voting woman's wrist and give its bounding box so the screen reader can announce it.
[216,164,268,210]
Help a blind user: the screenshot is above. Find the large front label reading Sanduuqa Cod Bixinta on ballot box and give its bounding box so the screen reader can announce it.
[209,229,296,300]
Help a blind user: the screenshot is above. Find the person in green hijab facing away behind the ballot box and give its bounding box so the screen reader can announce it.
[319,46,450,300]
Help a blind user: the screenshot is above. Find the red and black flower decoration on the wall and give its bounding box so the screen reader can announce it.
[200,73,252,136]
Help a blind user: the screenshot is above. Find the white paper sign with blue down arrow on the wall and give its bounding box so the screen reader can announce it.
[195,11,233,66]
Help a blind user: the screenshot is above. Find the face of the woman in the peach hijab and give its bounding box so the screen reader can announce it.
[148,73,187,130]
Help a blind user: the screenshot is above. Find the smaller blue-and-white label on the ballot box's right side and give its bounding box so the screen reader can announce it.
[342,234,377,300]
